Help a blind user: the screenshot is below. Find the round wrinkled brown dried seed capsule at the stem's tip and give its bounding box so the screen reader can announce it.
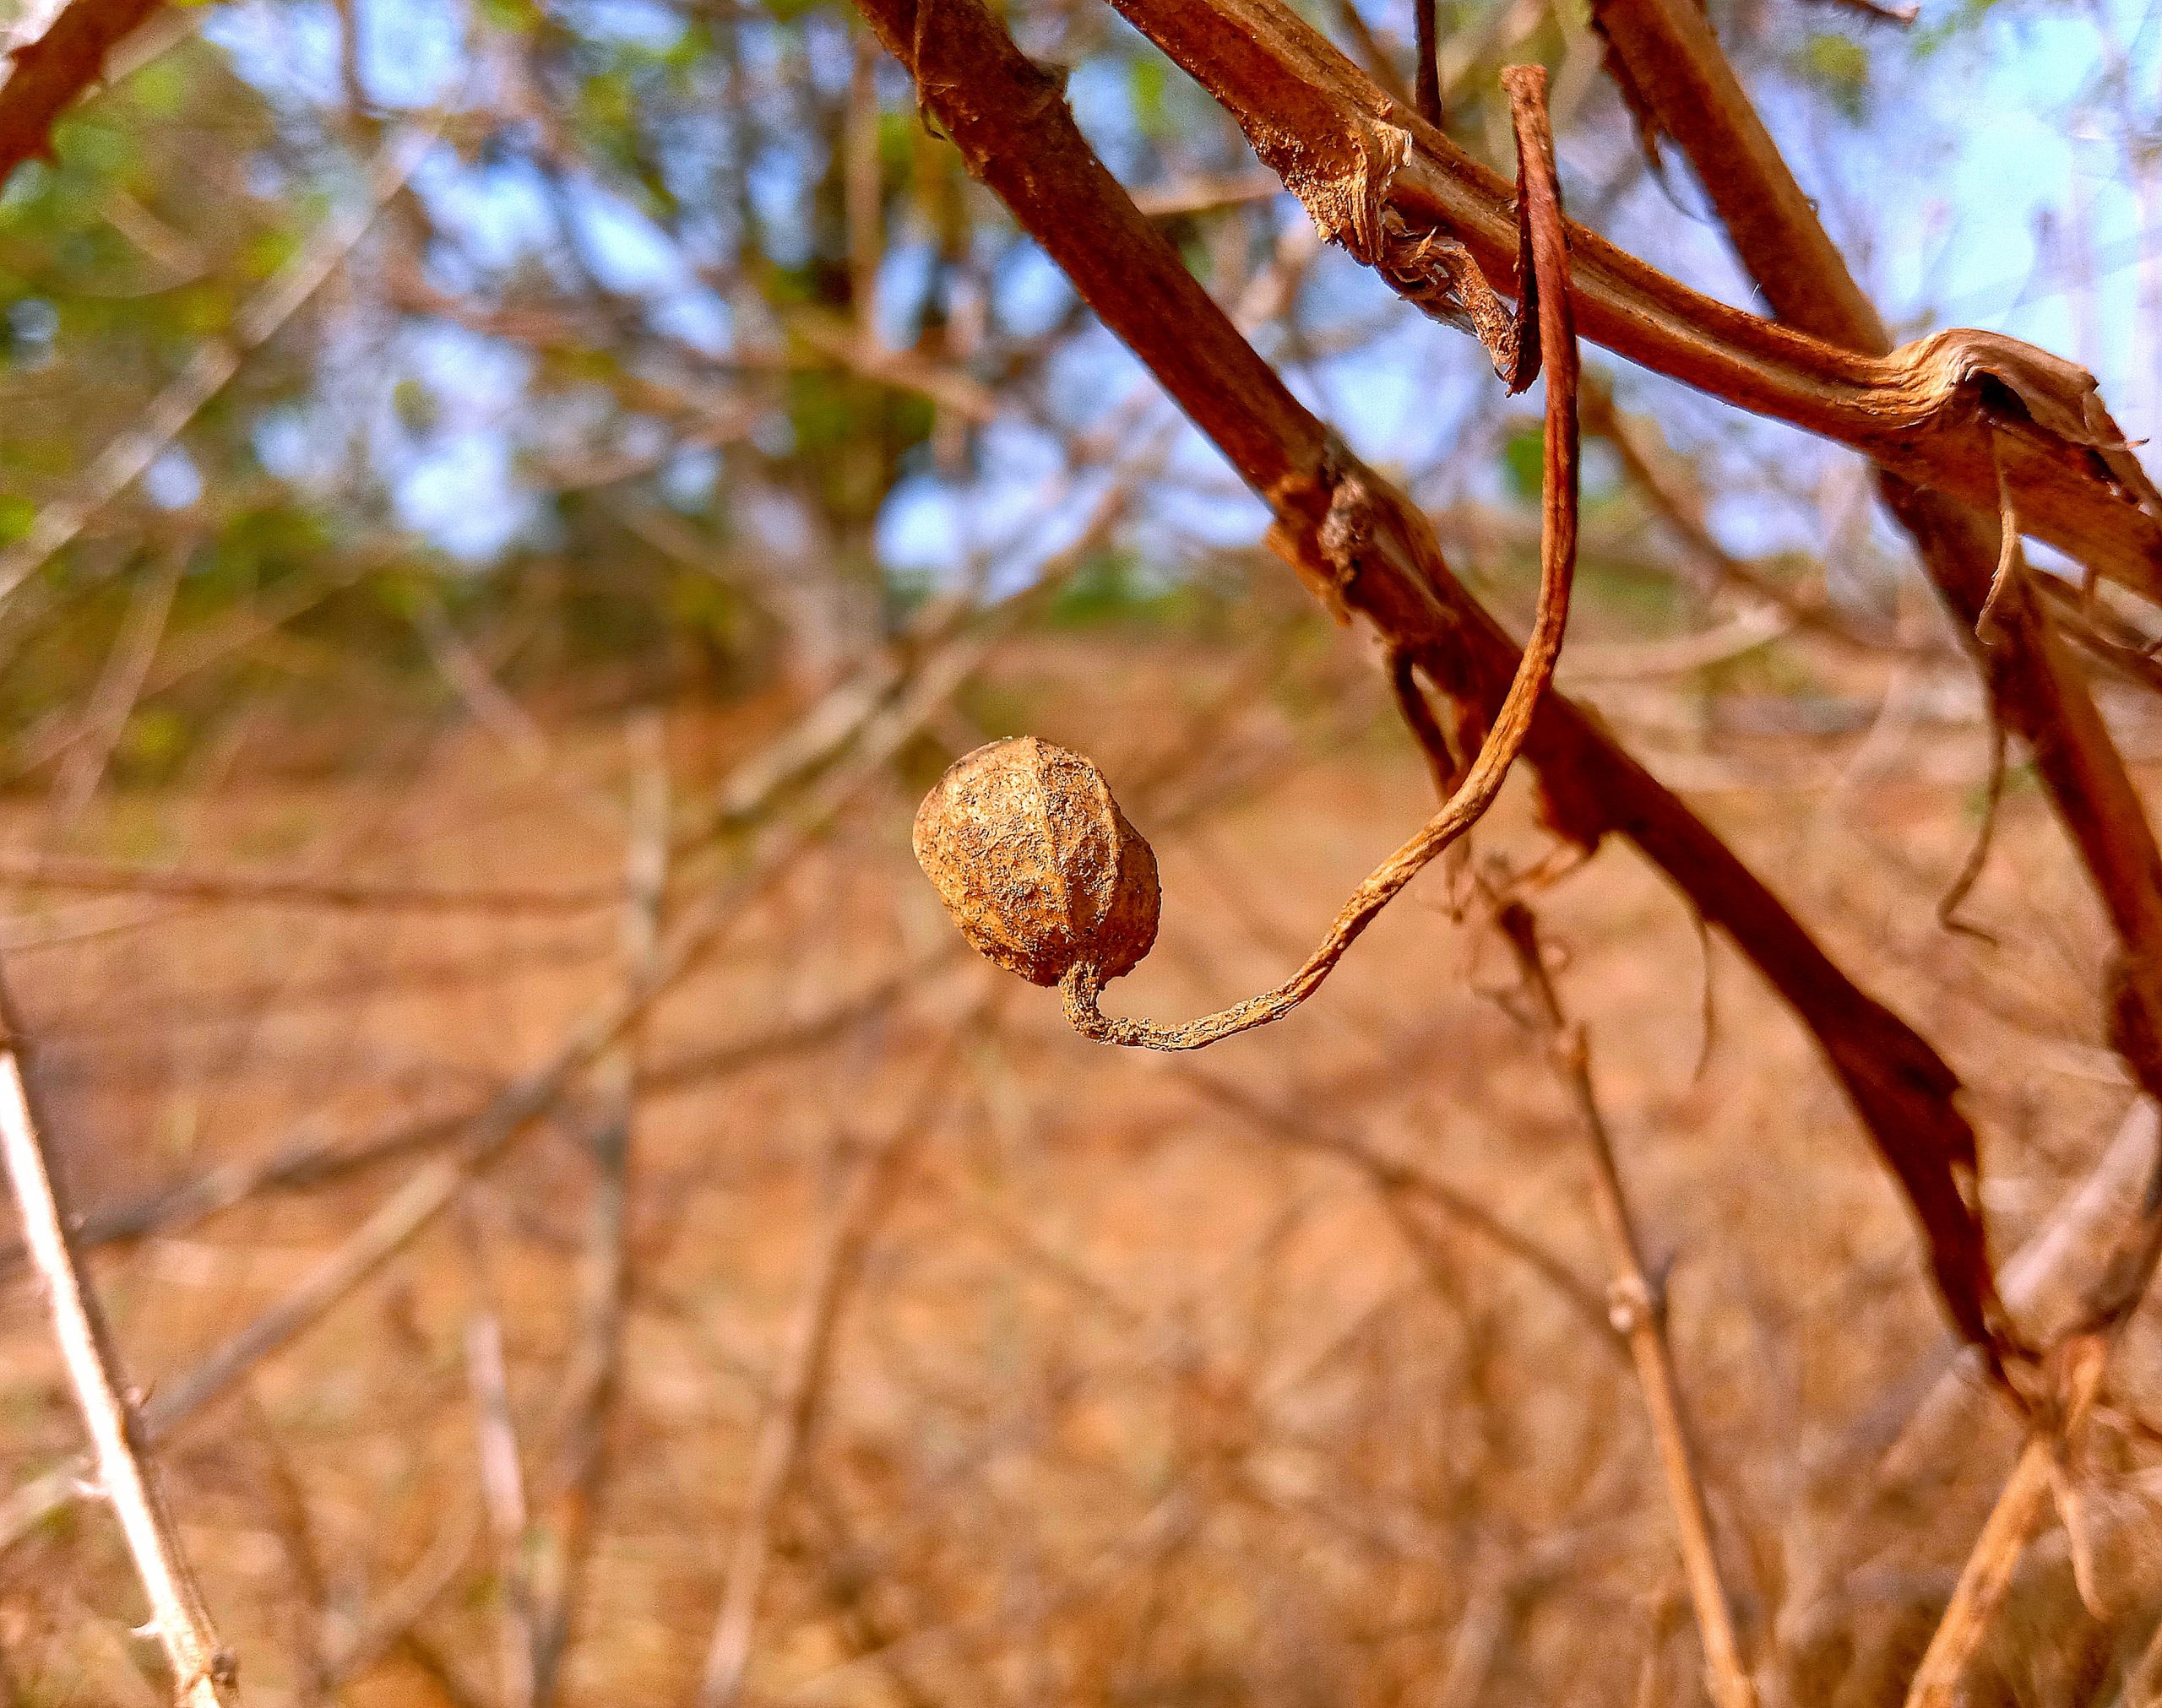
[915,735,1161,984]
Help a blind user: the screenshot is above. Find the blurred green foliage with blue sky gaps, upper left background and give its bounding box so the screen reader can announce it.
[0,0,2006,804]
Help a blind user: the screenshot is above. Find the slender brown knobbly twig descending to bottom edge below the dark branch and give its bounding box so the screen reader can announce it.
[1497,899,1757,1708]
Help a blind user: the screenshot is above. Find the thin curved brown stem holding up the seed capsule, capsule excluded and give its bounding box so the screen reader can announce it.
[1059,65,1578,1051]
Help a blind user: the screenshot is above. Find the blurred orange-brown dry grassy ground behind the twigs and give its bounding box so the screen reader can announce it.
[0,618,2162,1708]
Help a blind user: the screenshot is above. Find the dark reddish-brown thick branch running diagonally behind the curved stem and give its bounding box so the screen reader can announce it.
[858,0,1997,1345]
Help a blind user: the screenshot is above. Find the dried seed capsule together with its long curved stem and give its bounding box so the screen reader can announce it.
[916,65,1578,1051]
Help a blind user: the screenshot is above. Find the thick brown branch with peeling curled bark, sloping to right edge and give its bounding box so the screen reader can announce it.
[1113,0,2162,597]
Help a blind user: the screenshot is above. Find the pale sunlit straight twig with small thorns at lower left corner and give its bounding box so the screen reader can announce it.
[0,968,240,1708]
